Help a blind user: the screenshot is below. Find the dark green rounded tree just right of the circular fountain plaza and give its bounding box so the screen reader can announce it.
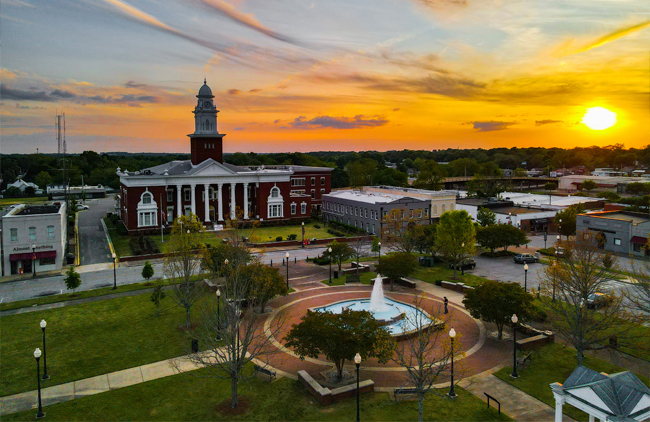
[463,280,533,340]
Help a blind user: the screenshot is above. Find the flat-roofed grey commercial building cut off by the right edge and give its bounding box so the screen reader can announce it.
[576,211,650,256]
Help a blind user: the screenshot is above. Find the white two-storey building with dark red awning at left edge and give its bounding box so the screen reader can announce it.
[2,202,67,276]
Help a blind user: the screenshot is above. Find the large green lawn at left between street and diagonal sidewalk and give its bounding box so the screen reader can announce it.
[0,293,215,396]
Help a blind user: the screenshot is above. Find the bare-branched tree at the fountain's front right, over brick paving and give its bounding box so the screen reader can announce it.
[392,296,461,422]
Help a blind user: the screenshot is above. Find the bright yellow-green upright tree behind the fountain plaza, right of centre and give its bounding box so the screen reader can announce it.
[436,210,476,280]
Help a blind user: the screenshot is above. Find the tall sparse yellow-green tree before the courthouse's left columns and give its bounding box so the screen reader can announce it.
[163,214,205,329]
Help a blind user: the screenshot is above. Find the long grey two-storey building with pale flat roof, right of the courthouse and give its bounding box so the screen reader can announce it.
[322,189,431,234]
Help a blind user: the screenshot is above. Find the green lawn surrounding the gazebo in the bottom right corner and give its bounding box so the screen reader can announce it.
[494,344,648,421]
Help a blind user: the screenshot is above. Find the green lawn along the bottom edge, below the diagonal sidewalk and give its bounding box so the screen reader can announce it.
[3,369,511,421]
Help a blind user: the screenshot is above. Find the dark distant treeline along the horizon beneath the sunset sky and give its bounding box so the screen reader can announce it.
[0,144,650,189]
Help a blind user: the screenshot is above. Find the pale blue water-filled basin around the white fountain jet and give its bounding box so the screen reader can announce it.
[311,298,443,340]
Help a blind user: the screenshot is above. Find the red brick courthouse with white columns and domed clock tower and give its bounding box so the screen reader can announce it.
[117,82,332,233]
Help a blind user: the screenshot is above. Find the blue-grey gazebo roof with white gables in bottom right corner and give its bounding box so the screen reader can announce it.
[562,366,650,421]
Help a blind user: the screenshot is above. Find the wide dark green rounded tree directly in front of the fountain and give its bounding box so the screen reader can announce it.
[284,309,394,379]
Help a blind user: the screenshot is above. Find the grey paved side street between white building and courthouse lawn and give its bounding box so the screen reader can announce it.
[79,195,115,265]
